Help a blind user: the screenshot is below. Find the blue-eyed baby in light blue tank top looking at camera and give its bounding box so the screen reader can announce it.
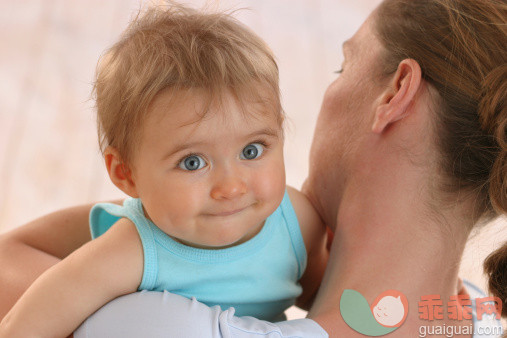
[0,5,328,337]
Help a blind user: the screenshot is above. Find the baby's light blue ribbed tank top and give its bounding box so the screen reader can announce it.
[90,192,307,321]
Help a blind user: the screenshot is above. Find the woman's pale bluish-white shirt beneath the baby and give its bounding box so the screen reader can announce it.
[74,281,502,338]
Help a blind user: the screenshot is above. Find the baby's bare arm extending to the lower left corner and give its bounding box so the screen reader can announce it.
[0,219,143,337]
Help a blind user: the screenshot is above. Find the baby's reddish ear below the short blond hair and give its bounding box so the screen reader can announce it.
[104,146,139,198]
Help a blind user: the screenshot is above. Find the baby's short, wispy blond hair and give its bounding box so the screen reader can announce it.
[93,2,283,165]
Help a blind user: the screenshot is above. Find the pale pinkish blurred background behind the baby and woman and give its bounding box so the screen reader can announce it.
[0,0,507,322]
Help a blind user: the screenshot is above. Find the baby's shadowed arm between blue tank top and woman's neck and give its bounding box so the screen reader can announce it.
[287,187,329,310]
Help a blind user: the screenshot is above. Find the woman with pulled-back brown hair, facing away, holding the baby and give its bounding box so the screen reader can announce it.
[0,0,507,337]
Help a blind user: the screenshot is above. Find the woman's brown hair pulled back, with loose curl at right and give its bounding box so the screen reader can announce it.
[375,0,507,315]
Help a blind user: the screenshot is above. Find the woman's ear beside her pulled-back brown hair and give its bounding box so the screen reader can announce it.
[372,59,422,134]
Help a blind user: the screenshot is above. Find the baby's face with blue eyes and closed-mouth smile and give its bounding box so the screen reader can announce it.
[128,90,285,248]
